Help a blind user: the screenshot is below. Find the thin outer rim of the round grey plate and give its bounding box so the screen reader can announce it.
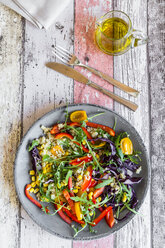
[13,103,151,241]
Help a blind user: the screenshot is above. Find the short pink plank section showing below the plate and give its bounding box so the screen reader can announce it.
[73,235,114,248]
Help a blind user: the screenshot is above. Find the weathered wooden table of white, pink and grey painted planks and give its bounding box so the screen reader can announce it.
[0,0,165,248]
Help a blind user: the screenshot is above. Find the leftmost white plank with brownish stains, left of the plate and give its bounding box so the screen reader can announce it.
[0,4,22,248]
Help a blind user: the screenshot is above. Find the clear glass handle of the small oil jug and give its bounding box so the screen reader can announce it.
[131,29,148,48]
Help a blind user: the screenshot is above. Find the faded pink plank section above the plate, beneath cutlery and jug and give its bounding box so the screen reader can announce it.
[74,0,113,109]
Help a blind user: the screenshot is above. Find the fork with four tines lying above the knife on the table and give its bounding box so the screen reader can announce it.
[52,46,139,97]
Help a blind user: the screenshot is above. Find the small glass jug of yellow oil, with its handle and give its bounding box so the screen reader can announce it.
[95,10,147,55]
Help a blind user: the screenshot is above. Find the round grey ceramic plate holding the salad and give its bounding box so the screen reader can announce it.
[14,104,150,240]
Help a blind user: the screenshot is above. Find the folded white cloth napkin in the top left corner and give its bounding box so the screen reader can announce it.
[0,0,70,29]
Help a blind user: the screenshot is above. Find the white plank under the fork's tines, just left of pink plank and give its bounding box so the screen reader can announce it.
[20,1,74,248]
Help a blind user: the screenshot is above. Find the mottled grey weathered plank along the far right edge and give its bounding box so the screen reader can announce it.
[148,0,165,248]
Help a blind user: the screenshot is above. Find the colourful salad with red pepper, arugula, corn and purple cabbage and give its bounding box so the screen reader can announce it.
[25,111,142,235]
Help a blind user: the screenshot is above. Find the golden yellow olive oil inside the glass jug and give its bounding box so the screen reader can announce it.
[95,17,132,55]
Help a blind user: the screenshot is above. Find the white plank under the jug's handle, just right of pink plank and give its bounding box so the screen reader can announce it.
[114,0,151,248]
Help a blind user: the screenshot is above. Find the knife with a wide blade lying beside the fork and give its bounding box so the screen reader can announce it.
[46,62,138,111]
